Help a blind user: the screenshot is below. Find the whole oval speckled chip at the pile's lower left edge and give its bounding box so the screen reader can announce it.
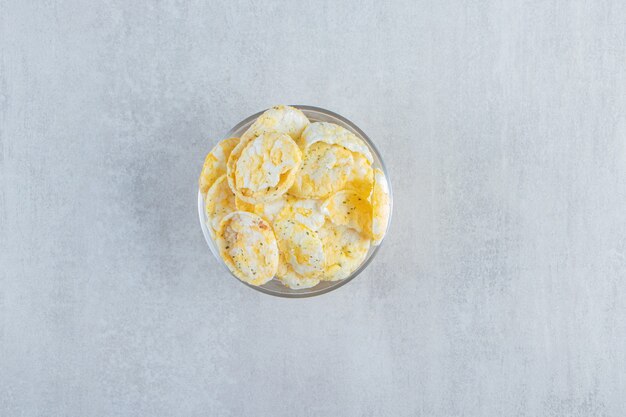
[217,211,278,285]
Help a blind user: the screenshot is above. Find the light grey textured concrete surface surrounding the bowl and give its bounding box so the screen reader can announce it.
[0,0,626,417]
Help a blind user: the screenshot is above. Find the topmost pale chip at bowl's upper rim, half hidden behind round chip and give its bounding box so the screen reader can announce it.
[241,105,310,142]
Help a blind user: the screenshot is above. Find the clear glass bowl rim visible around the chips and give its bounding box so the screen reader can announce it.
[198,105,393,298]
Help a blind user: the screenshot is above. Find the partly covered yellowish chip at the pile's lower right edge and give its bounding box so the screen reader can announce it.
[319,222,370,281]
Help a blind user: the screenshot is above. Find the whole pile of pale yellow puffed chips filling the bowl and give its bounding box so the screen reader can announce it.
[199,105,390,289]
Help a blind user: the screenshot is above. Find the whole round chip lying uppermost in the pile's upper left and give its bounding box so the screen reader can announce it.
[227,132,302,204]
